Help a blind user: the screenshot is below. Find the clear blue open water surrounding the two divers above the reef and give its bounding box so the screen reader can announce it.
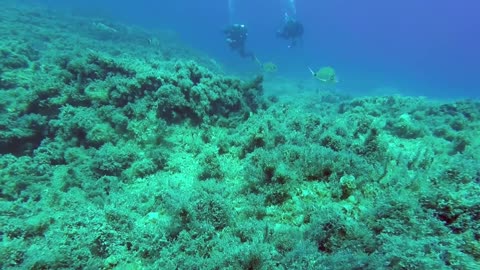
[38,0,480,98]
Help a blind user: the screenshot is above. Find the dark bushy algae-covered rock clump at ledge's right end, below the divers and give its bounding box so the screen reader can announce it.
[154,62,266,124]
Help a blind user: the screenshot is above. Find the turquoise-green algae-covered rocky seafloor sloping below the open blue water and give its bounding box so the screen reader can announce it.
[0,2,480,269]
